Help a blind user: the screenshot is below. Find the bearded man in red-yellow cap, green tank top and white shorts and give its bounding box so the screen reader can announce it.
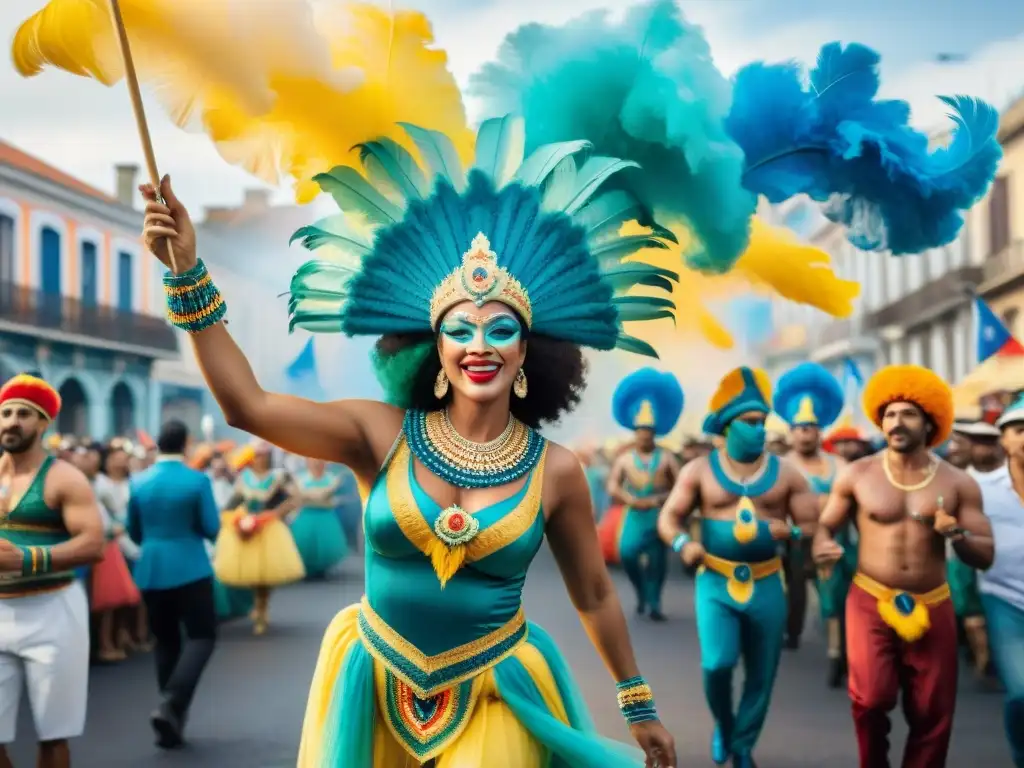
[0,375,103,768]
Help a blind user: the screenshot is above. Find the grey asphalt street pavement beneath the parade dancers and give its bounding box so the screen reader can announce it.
[11,548,1012,768]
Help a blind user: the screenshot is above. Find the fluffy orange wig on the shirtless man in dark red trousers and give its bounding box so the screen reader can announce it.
[863,366,954,447]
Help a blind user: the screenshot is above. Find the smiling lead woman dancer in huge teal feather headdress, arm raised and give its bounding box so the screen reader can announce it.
[142,119,676,768]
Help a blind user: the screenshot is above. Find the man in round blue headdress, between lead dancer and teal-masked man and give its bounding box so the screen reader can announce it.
[607,368,683,622]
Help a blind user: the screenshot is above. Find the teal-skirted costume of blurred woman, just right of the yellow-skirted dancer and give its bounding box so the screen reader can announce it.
[292,472,348,579]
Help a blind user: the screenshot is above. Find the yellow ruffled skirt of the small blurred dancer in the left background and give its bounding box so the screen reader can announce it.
[213,512,306,587]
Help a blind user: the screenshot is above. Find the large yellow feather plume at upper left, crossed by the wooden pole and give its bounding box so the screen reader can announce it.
[11,0,473,202]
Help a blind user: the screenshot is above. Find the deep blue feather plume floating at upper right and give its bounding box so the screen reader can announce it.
[726,43,1002,255]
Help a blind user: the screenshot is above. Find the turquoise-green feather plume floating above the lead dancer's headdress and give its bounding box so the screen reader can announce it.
[470,0,756,272]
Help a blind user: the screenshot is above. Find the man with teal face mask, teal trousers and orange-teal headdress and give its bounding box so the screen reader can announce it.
[658,368,818,768]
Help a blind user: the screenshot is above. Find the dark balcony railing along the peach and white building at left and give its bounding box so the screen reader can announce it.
[0,281,178,352]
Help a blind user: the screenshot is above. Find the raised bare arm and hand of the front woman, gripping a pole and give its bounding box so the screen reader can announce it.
[139,176,400,477]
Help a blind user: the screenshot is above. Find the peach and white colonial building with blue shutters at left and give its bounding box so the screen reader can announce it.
[0,142,178,438]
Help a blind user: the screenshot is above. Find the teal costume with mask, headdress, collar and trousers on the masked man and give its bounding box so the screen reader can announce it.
[695,368,786,768]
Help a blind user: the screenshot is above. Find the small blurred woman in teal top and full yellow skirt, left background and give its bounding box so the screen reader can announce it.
[213,442,305,635]
